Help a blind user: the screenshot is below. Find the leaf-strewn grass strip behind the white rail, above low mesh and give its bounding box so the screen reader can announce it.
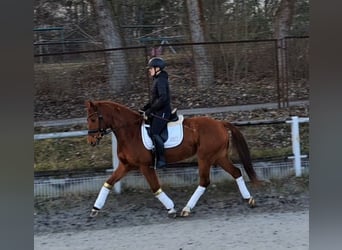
[34,119,309,171]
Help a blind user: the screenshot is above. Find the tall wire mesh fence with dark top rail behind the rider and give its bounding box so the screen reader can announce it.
[34,38,309,121]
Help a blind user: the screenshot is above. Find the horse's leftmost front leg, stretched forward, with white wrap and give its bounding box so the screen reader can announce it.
[90,162,129,217]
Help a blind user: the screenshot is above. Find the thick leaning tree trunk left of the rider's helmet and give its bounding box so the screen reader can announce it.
[94,0,130,91]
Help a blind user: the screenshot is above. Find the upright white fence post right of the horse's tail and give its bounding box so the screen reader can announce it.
[291,116,302,176]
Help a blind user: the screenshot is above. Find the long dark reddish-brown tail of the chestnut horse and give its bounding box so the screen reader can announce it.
[223,121,259,184]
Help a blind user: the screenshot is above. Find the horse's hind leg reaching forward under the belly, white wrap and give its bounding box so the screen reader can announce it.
[181,160,211,217]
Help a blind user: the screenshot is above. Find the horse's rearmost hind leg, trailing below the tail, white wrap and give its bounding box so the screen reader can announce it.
[217,157,255,207]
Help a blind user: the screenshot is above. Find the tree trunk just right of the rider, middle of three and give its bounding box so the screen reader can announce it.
[186,0,214,86]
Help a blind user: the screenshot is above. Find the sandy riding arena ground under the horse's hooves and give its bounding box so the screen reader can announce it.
[34,176,309,250]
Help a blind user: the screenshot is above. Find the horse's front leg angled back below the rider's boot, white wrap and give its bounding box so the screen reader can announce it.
[140,166,177,217]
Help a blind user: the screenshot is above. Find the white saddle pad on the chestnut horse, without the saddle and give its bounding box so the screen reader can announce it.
[141,115,184,150]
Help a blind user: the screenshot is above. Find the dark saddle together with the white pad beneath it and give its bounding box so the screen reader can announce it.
[141,109,184,150]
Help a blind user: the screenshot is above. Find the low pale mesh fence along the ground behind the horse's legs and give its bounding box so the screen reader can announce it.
[34,159,309,198]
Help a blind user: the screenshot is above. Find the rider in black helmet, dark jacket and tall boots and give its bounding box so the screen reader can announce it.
[142,57,171,168]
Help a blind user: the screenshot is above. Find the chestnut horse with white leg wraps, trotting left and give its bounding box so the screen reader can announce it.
[86,101,258,217]
